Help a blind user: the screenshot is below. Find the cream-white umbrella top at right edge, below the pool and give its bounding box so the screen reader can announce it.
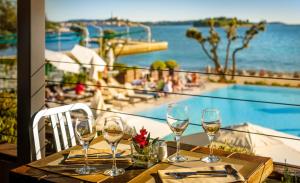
[216,123,300,165]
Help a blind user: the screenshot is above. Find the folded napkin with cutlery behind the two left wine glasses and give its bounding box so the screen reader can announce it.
[64,149,131,164]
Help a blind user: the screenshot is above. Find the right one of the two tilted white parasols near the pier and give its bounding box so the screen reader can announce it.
[71,45,106,80]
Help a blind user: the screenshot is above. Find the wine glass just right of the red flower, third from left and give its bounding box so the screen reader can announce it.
[167,103,189,162]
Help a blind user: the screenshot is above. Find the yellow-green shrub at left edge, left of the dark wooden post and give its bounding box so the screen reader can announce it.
[0,92,17,143]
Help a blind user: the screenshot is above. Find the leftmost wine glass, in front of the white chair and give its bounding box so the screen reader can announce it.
[75,116,96,175]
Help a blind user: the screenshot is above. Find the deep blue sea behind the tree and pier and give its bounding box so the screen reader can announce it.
[0,24,300,72]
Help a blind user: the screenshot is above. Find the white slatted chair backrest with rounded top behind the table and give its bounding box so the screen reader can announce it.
[32,103,93,160]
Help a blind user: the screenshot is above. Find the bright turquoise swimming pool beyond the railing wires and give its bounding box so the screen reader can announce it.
[138,85,300,136]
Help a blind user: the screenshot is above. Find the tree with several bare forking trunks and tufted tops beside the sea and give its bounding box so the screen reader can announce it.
[186,18,265,80]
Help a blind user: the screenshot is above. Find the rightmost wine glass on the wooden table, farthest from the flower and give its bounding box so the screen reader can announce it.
[201,109,221,163]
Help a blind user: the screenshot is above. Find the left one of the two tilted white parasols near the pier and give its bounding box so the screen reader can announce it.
[45,50,80,73]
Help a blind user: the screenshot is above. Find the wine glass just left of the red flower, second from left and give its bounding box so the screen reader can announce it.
[102,116,125,177]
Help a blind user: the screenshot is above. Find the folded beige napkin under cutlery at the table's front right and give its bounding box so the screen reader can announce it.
[158,165,245,183]
